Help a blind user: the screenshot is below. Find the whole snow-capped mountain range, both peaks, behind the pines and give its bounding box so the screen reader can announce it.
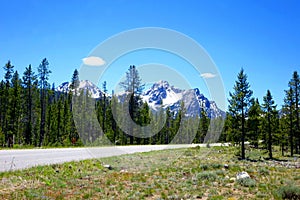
[56,80,225,118]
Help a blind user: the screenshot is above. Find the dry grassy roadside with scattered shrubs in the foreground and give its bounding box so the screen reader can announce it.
[0,147,300,199]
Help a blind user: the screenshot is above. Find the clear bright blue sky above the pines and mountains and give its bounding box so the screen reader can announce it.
[0,0,300,110]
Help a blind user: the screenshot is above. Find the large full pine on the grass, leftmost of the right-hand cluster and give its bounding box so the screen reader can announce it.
[229,69,253,159]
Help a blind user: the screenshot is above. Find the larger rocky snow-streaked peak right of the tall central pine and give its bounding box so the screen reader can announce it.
[142,81,225,118]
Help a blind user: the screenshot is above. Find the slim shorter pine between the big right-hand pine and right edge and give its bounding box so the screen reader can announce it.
[262,90,276,159]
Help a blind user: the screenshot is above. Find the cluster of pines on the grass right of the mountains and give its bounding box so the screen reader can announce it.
[220,69,300,159]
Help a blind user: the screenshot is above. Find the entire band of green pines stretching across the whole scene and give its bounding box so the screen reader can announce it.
[0,58,300,159]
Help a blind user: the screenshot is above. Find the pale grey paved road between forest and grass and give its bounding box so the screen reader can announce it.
[0,144,211,172]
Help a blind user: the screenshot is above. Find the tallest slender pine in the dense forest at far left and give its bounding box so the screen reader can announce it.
[38,58,51,147]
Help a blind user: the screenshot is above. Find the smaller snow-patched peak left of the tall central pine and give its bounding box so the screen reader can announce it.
[56,80,104,99]
